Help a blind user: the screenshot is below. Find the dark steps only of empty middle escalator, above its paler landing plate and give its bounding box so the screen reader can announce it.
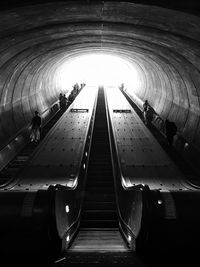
[81,90,118,232]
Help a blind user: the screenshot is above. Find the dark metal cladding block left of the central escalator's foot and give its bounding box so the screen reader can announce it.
[0,187,59,266]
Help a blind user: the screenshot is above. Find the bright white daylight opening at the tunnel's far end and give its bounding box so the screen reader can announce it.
[58,54,138,89]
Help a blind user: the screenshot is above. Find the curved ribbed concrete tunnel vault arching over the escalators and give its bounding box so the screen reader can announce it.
[0,1,200,153]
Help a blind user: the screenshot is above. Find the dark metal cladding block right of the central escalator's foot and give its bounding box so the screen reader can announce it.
[136,187,200,266]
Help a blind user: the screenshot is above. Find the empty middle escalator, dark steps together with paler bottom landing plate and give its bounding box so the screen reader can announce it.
[62,88,141,266]
